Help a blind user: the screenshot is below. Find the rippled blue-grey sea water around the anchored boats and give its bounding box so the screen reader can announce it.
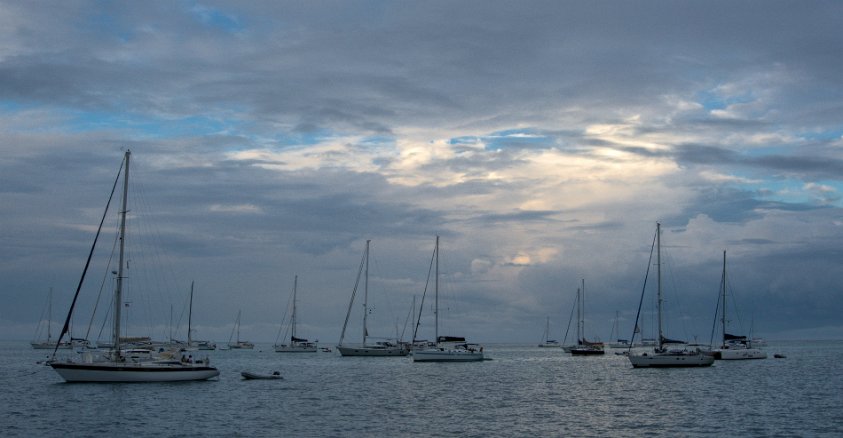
[0,341,843,437]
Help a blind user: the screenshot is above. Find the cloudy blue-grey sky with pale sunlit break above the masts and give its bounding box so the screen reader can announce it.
[0,0,843,343]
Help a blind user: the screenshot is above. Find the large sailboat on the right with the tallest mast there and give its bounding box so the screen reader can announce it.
[627,223,714,368]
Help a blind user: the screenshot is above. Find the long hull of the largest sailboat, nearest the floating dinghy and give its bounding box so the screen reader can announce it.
[50,362,220,382]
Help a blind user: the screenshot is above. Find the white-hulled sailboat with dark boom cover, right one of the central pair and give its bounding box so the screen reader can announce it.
[413,236,483,362]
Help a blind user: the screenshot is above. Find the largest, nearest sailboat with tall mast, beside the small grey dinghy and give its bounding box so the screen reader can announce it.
[48,150,220,382]
